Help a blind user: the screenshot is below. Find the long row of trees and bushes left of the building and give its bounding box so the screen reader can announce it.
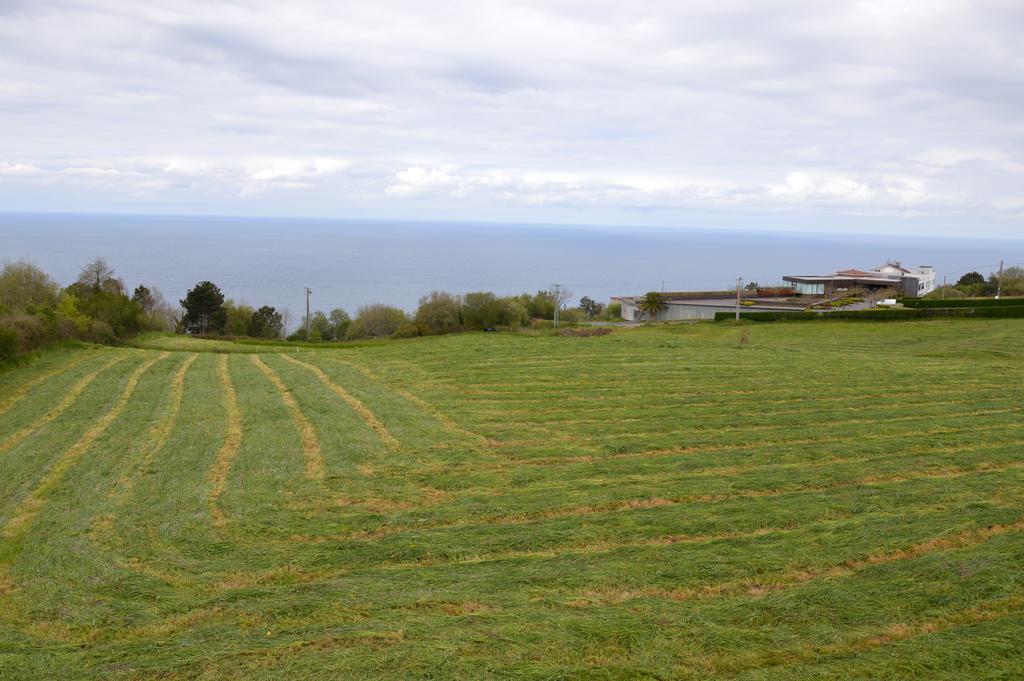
[0,258,622,360]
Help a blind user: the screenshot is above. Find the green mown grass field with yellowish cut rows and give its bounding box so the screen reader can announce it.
[0,320,1024,681]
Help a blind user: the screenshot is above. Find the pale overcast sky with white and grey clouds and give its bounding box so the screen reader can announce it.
[0,0,1024,238]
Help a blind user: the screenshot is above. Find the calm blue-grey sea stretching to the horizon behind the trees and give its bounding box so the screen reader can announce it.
[0,213,1024,326]
